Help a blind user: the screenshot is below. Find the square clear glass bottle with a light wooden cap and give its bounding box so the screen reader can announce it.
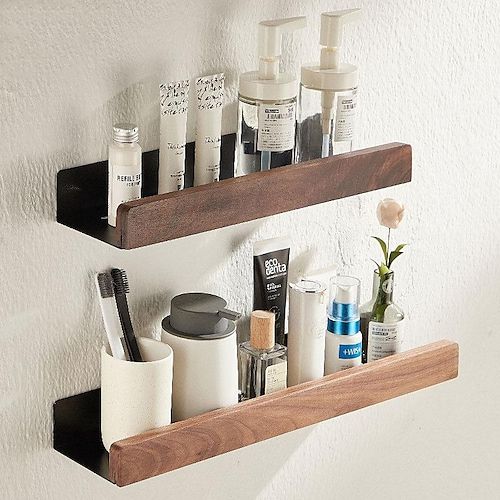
[238,310,287,401]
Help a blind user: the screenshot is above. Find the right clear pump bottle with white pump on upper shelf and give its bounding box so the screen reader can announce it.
[295,9,361,162]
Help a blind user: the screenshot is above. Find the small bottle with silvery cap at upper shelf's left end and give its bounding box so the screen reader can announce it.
[108,123,142,226]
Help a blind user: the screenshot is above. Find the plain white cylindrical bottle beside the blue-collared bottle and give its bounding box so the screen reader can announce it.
[288,279,326,387]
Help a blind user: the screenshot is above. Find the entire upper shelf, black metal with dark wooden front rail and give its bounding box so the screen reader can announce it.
[57,134,412,249]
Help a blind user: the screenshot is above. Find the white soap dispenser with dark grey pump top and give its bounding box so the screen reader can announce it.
[161,293,241,421]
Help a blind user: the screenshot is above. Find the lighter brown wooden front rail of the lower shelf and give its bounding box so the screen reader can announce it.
[109,340,458,486]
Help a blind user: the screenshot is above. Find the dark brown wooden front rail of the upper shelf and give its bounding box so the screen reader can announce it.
[117,143,412,249]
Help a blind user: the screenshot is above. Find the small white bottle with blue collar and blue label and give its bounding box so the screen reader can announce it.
[325,276,362,375]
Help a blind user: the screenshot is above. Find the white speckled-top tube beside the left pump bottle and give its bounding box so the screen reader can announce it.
[194,73,224,186]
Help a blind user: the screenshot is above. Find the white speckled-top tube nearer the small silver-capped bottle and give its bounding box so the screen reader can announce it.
[158,80,189,194]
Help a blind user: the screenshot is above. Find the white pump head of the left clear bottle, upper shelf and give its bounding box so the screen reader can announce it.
[258,16,306,80]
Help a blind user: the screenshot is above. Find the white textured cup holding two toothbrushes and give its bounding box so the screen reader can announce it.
[101,337,174,451]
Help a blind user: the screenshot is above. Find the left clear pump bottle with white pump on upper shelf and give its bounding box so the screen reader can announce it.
[234,16,306,176]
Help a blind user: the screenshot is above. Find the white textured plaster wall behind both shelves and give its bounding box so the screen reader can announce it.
[0,0,500,500]
